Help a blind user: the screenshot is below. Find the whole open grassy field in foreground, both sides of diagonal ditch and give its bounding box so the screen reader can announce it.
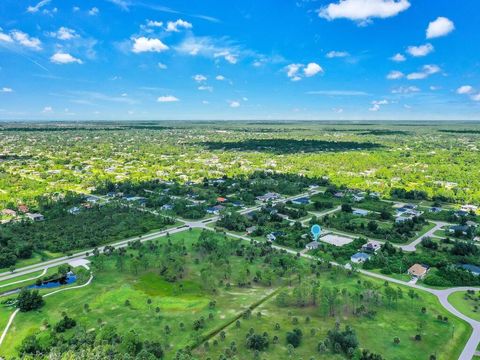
[0,230,470,359]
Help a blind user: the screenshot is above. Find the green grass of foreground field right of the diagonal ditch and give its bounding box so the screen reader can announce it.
[195,277,471,360]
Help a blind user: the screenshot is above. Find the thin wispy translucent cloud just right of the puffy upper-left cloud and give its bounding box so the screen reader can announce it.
[175,36,244,64]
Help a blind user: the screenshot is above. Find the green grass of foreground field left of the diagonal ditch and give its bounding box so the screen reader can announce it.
[0,231,274,358]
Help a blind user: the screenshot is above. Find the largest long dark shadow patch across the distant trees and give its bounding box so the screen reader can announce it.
[201,139,384,154]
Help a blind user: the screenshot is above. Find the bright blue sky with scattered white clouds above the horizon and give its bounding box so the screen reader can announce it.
[0,0,480,120]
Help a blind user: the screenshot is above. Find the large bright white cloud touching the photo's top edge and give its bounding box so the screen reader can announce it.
[318,0,410,25]
